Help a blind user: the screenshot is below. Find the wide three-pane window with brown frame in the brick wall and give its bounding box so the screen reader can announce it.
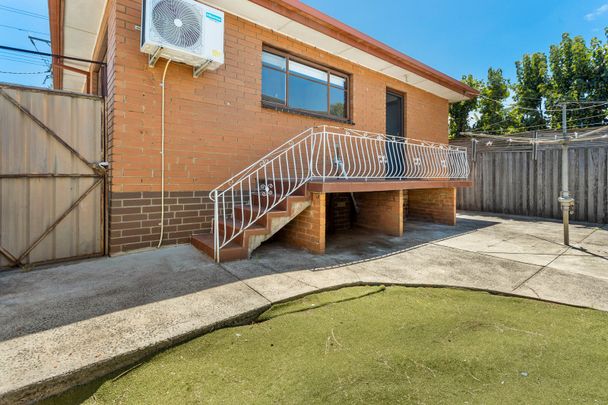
[262,50,348,121]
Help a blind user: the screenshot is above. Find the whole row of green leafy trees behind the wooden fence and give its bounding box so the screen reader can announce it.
[450,28,608,137]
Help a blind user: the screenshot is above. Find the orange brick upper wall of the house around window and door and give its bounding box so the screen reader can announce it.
[108,0,448,251]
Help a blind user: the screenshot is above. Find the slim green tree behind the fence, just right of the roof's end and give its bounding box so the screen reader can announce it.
[475,68,511,131]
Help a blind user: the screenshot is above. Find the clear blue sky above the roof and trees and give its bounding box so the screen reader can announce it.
[0,0,608,86]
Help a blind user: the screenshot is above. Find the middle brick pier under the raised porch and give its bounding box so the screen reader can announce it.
[355,190,403,236]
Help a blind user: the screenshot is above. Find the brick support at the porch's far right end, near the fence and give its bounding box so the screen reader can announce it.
[408,188,456,225]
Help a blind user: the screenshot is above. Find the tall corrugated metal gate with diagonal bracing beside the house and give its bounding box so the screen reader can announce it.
[0,84,107,269]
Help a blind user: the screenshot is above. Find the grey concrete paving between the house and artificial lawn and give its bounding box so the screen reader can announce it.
[0,213,608,403]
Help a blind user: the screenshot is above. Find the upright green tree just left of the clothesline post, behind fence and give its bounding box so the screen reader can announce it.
[510,52,549,132]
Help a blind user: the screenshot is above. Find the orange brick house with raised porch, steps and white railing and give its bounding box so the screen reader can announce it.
[49,0,477,260]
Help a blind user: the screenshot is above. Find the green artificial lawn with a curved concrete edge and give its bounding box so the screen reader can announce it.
[47,287,608,404]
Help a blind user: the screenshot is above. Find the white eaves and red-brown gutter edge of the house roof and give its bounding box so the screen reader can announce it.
[49,0,479,102]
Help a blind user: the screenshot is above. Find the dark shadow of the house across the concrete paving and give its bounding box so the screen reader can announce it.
[0,218,498,341]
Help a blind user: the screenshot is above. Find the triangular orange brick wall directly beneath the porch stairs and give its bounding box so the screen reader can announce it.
[276,193,326,253]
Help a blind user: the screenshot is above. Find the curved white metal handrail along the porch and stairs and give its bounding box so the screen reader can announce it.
[209,126,469,261]
